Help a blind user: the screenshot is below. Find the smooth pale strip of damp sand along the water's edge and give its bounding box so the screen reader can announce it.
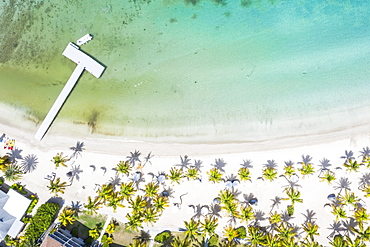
[0,100,370,155]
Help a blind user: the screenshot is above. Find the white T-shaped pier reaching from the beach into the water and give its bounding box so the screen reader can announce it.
[35,43,105,141]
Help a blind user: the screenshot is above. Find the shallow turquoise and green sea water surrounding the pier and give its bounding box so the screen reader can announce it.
[0,0,370,141]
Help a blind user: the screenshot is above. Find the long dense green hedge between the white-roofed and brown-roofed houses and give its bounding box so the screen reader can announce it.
[24,202,60,239]
